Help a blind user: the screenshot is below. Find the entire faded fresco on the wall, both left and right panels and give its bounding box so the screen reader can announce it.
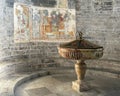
[14,0,76,42]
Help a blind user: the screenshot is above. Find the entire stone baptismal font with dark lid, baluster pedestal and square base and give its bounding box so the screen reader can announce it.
[58,34,103,92]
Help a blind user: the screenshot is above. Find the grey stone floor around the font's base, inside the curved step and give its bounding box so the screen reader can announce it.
[15,74,120,96]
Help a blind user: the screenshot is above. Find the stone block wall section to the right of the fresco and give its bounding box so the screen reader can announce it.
[77,0,120,61]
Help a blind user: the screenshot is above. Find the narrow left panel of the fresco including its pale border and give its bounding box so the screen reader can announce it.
[14,4,29,42]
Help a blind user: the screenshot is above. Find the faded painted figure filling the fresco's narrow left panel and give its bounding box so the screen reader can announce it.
[16,5,29,41]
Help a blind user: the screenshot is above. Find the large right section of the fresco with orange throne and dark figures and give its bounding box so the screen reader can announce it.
[41,9,75,40]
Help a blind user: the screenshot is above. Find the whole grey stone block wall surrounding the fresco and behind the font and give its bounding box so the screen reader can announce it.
[0,0,120,71]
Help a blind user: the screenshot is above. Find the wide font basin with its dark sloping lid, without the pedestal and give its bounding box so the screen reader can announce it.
[58,39,103,60]
